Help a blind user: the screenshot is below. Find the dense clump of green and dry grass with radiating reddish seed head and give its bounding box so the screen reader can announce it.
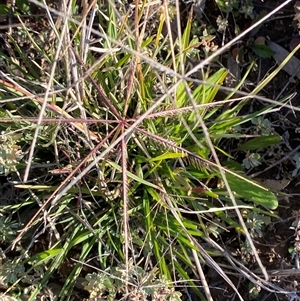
[0,1,296,300]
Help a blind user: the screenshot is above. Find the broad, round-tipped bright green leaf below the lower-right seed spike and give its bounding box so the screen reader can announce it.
[226,174,278,209]
